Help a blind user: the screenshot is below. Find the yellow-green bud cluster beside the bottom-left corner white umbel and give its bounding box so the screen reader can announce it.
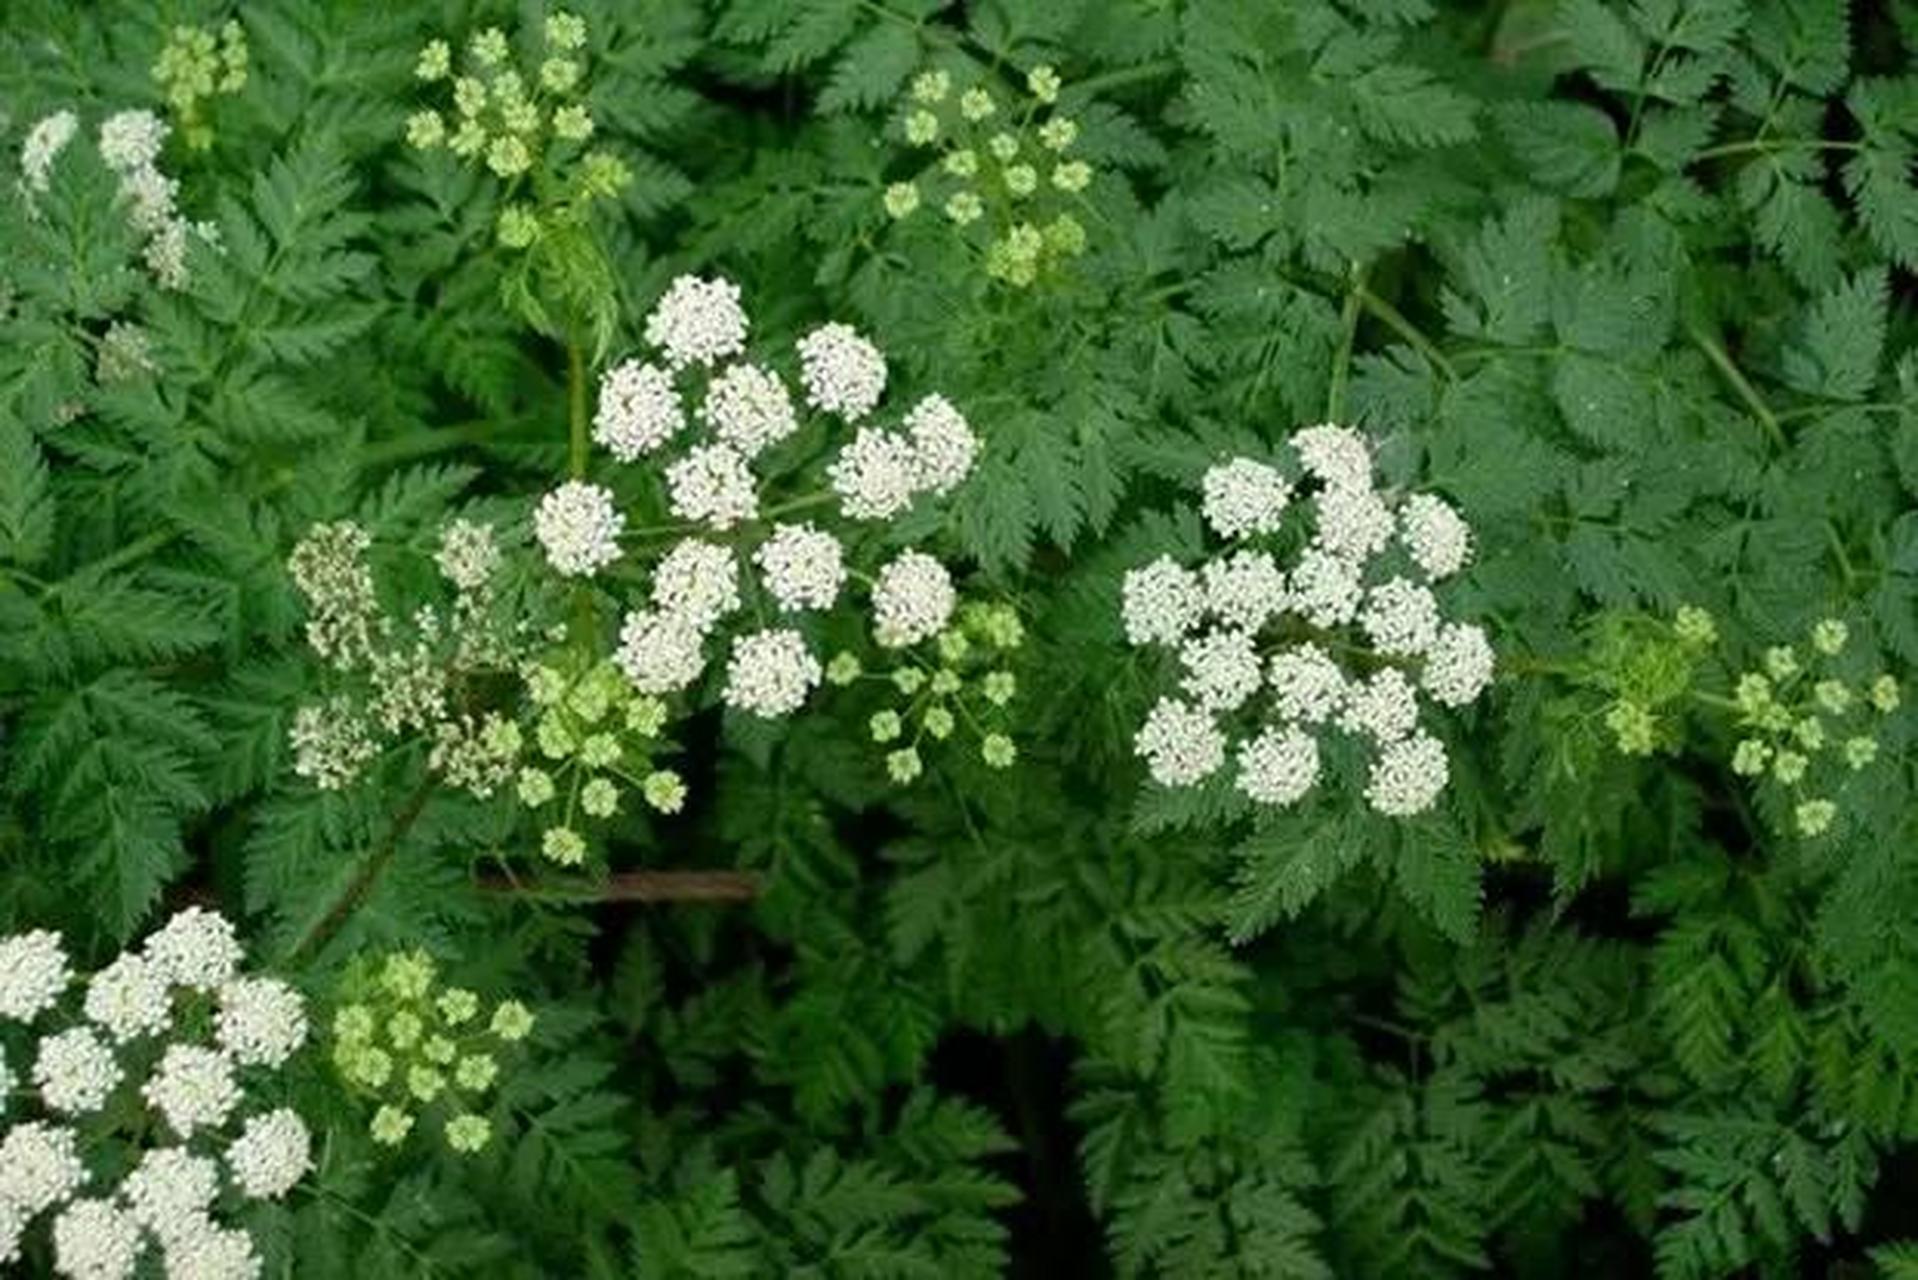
[332,950,533,1155]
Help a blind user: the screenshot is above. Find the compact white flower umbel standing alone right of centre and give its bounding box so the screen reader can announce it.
[1122,424,1492,818]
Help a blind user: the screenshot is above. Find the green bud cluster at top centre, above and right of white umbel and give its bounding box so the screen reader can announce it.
[882,65,1093,288]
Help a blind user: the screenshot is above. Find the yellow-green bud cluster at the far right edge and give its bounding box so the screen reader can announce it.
[1732,618,1901,837]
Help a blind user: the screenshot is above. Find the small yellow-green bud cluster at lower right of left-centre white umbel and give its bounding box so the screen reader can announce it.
[827,601,1026,787]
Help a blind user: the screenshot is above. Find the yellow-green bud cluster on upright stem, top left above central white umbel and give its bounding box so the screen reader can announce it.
[407,10,633,249]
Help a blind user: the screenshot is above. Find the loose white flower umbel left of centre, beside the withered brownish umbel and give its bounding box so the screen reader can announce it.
[579,276,978,718]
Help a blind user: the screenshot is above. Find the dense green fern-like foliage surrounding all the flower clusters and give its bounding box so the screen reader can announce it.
[0,0,1918,1280]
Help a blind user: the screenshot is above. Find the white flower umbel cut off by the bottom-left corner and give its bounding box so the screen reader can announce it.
[0,908,313,1280]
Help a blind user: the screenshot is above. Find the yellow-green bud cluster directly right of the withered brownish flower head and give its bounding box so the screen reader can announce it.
[516,658,687,867]
